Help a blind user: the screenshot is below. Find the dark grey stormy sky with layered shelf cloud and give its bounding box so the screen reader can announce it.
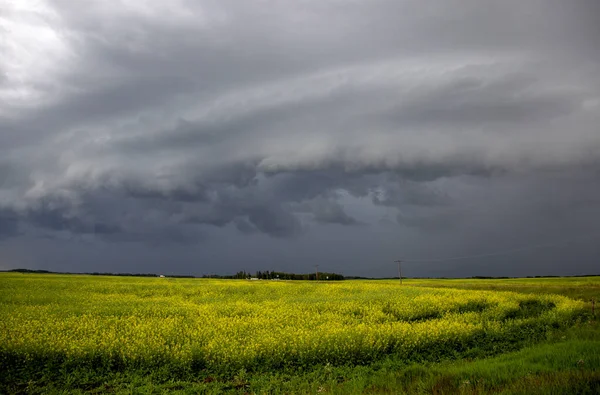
[0,0,600,276]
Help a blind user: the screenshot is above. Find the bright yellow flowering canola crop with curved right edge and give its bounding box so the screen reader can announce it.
[0,273,584,384]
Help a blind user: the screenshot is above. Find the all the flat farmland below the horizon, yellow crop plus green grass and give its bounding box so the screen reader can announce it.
[0,273,600,393]
